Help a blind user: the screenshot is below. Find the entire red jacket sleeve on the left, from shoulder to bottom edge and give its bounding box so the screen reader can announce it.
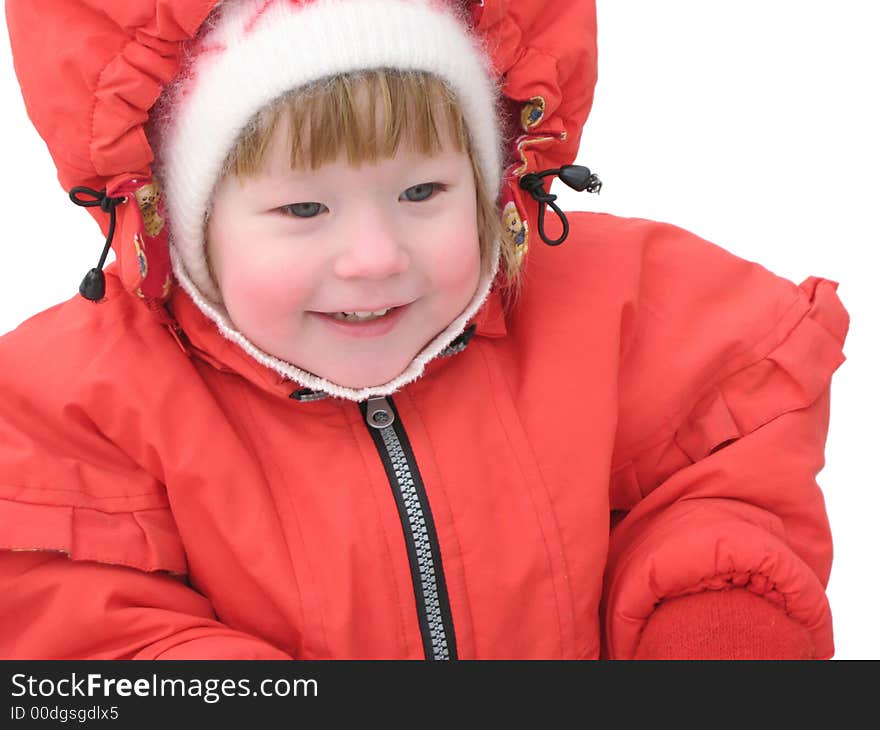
[0,298,289,659]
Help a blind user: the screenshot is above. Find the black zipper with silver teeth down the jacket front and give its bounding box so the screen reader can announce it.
[359,396,458,660]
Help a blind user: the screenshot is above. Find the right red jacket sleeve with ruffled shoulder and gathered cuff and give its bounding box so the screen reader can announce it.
[600,222,849,659]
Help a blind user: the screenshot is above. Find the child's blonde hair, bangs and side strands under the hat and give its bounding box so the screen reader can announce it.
[223,69,519,298]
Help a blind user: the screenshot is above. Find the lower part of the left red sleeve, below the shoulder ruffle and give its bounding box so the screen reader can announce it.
[0,550,291,659]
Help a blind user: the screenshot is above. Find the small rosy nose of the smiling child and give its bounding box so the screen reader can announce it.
[334,205,410,279]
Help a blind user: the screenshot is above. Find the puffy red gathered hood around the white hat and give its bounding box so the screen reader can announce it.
[6,0,596,303]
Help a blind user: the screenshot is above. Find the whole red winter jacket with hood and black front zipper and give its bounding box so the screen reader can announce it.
[0,0,849,659]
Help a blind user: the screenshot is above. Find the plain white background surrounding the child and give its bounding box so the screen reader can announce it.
[0,0,880,659]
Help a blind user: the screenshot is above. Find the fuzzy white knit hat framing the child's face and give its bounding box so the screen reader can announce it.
[154,0,502,400]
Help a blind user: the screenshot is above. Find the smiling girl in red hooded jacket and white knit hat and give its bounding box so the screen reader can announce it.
[0,0,848,659]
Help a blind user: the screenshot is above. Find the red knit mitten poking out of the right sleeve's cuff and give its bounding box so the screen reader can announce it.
[633,588,814,659]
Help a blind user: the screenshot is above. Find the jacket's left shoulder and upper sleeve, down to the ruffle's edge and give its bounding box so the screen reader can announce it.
[0,275,186,573]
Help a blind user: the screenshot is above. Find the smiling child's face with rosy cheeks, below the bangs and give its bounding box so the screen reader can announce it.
[207,112,480,388]
